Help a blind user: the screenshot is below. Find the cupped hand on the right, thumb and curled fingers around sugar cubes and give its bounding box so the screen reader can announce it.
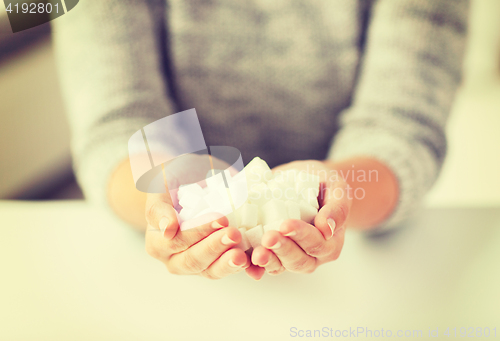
[248,160,352,275]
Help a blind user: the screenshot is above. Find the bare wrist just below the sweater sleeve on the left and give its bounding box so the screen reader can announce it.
[107,159,146,231]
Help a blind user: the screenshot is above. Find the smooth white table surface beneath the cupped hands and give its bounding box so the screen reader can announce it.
[0,201,500,340]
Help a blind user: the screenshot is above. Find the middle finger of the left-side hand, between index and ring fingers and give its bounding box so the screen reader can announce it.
[167,227,241,274]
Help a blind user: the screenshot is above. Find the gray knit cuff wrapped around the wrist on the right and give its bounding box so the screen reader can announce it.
[328,126,438,232]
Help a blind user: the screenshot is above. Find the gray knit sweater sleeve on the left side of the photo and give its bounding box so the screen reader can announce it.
[53,0,178,207]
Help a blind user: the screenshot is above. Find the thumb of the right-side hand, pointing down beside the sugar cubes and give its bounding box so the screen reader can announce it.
[314,180,352,240]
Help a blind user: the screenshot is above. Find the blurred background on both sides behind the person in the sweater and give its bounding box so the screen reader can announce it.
[0,0,500,206]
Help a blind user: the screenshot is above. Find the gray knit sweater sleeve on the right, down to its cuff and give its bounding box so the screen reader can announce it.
[328,0,468,229]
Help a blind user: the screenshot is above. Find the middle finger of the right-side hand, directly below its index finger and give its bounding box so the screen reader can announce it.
[262,231,317,273]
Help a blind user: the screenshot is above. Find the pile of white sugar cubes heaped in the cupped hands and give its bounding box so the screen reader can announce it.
[177,157,320,251]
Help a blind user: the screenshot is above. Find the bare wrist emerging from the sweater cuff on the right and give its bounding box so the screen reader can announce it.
[326,157,399,230]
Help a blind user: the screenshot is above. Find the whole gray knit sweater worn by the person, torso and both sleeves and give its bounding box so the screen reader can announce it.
[53,0,468,227]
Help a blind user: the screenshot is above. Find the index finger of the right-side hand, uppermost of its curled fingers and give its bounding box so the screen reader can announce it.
[280,219,337,258]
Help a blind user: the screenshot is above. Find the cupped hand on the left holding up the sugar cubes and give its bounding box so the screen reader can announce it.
[146,193,251,279]
